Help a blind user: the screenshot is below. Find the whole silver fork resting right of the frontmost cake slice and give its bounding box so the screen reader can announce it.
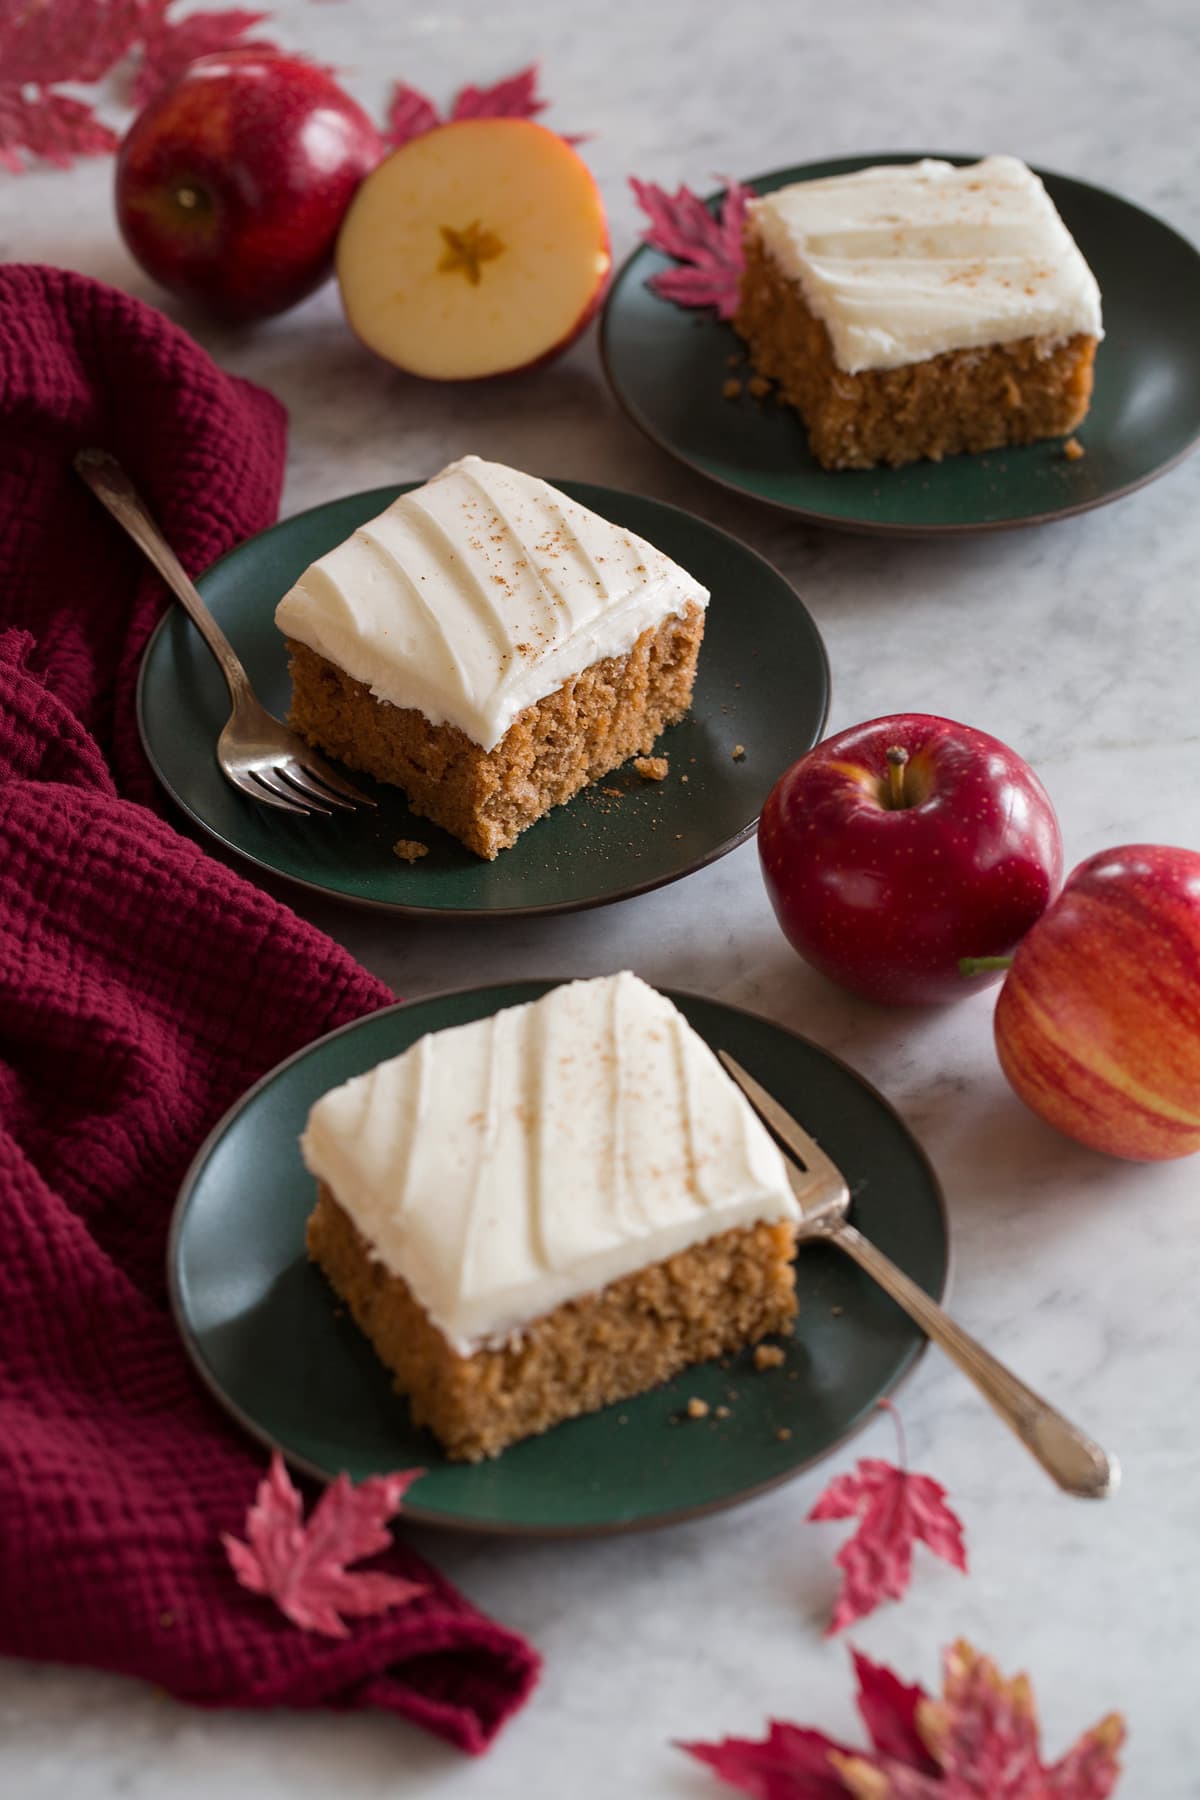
[718,1049,1121,1499]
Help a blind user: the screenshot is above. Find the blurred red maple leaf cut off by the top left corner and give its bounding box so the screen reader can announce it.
[0,0,144,175]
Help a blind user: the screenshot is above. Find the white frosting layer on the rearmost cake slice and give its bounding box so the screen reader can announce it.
[750,157,1103,374]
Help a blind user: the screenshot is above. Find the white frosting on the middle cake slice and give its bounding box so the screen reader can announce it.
[275,455,709,751]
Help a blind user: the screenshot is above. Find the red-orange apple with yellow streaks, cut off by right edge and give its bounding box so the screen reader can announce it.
[995,844,1200,1163]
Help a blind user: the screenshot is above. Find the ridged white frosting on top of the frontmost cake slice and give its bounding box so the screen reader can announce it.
[300,972,799,1355]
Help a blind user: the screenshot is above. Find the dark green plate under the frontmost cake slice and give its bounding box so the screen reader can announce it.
[169,981,948,1535]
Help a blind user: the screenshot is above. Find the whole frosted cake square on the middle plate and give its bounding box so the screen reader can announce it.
[275,455,709,859]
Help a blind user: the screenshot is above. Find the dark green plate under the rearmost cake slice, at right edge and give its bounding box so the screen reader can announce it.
[601,151,1200,536]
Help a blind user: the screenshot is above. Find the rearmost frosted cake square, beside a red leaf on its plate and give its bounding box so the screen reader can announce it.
[734,157,1103,468]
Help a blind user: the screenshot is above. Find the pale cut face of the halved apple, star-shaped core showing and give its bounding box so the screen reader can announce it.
[336,119,612,382]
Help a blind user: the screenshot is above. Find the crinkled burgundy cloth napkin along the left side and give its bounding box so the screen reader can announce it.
[0,266,538,1751]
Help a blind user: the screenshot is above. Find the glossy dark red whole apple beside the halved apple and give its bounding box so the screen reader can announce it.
[117,50,383,319]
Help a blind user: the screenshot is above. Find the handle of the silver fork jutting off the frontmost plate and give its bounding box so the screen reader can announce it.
[822,1222,1121,1499]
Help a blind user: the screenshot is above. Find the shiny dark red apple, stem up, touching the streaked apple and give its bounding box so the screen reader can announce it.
[759,713,1063,1004]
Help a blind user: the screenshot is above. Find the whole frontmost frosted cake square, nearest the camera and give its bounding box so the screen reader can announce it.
[300,974,799,1462]
